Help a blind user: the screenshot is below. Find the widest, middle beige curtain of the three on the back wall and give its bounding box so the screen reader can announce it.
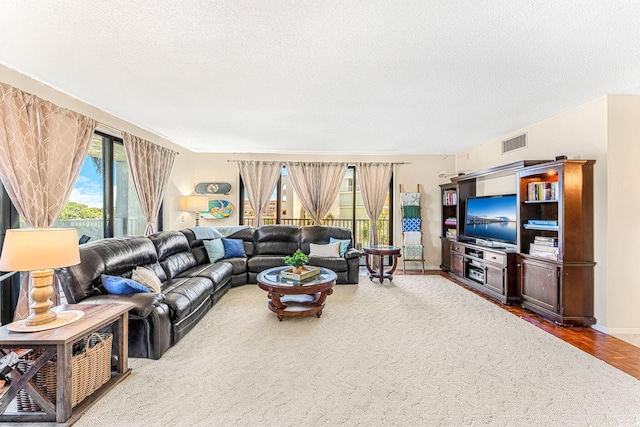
[285,162,347,225]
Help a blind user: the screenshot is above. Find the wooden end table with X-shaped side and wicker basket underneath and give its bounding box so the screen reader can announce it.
[0,304,132,423]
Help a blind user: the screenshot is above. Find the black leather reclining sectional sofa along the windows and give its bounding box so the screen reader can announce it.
[56,225,361,359]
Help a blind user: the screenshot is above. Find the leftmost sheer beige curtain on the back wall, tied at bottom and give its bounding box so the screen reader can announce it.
[238,160,282,227]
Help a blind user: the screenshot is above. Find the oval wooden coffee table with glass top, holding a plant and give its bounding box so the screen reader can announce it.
[257,266,337,321]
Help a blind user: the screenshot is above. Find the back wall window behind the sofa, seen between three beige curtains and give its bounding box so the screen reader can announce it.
[240,166,393,249]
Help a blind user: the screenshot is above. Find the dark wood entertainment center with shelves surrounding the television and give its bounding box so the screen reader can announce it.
[440,160,596,326]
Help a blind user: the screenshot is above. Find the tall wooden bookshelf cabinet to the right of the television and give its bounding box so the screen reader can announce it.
[517,160,596,326]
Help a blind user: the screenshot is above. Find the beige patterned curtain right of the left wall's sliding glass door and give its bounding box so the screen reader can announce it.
[122,132,178,236]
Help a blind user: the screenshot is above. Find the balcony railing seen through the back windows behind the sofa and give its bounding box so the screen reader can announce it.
[244,217,390,249]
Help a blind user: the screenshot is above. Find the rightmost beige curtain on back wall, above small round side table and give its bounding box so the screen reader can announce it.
[356,163,393,245]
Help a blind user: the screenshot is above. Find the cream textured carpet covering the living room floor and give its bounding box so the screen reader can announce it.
[76,276,640,426]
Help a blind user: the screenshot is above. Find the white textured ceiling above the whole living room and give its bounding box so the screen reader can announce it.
[0,0,640,154]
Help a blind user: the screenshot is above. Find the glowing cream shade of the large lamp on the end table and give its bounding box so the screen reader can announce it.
[0,228,80,271]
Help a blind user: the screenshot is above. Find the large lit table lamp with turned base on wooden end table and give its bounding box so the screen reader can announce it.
[0,228,80,331]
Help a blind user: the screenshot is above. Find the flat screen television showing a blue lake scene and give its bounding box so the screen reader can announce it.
[464,194,518,245]
